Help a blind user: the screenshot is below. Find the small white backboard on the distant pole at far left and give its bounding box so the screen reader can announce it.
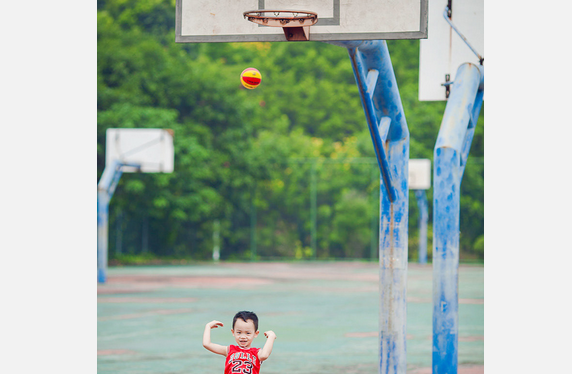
[105,129,175,173]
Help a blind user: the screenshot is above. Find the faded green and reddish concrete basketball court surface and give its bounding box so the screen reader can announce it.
[97,262,484,374]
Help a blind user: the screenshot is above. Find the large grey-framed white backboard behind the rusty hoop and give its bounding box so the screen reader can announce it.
[175,0,428,43]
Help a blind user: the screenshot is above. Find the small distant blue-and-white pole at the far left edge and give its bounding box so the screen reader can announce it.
[97,160,139,283]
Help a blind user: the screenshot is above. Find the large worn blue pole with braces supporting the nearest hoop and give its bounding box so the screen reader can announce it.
[329,40,409,374]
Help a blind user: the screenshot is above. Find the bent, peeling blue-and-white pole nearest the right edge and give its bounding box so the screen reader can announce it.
[433,63,484,374]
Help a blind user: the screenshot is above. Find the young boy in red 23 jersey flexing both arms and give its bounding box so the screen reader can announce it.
[203,311,276,374]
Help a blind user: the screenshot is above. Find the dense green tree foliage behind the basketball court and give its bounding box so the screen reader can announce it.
[97,0,484,259]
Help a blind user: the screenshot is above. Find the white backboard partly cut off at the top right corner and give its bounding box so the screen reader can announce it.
[419,0,485,101]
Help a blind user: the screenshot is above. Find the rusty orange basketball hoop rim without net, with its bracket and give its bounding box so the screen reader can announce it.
[243,9,318,41]
